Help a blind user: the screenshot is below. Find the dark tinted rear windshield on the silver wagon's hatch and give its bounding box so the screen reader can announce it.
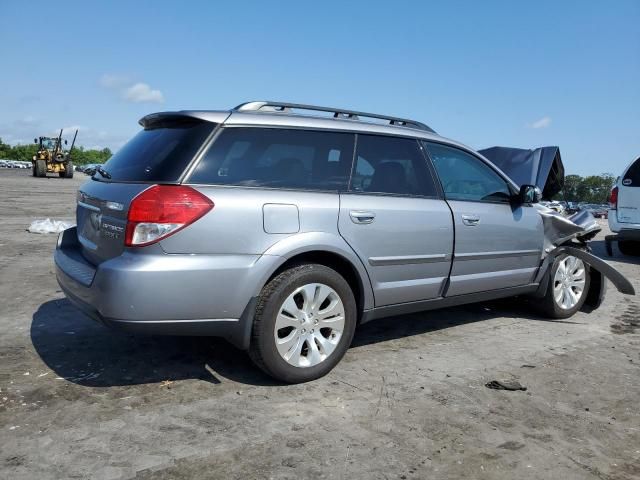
[93,119,215,182]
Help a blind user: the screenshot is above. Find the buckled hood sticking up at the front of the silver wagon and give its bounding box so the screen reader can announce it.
[478,147,564,200]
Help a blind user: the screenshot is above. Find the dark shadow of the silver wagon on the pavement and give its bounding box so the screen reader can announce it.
[31,299,577,387]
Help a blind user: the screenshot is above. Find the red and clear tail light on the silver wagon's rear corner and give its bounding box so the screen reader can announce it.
[124,185,213,247]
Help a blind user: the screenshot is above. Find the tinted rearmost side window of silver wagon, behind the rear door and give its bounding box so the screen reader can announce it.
[189,128,355,190]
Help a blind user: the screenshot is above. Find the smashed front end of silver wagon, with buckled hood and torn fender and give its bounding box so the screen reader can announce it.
[480,147,635,311]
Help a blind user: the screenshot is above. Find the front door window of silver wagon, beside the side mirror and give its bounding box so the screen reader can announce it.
[425,142,511,202]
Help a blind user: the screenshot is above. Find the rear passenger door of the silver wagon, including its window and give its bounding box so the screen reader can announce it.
[338,134,453,306]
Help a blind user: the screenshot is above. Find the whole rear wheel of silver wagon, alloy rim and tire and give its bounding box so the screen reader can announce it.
[249,264,357,383]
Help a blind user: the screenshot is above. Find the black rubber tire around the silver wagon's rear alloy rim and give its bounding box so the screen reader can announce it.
[249,264,357,383]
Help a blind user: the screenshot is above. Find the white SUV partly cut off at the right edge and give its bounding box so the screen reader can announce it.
[606,158,640,255]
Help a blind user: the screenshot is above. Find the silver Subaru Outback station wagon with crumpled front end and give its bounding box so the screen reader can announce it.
[55,102,633,383]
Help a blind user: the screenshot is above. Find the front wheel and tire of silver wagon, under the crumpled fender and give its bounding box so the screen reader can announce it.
[540,255,590,318]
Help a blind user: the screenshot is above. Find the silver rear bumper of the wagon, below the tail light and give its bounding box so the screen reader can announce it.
[54,228,278,348]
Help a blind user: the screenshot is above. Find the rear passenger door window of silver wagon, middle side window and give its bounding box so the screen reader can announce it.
[350,134,438,197]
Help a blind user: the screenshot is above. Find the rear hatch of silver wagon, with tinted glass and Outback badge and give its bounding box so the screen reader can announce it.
[76,114,216,265]
